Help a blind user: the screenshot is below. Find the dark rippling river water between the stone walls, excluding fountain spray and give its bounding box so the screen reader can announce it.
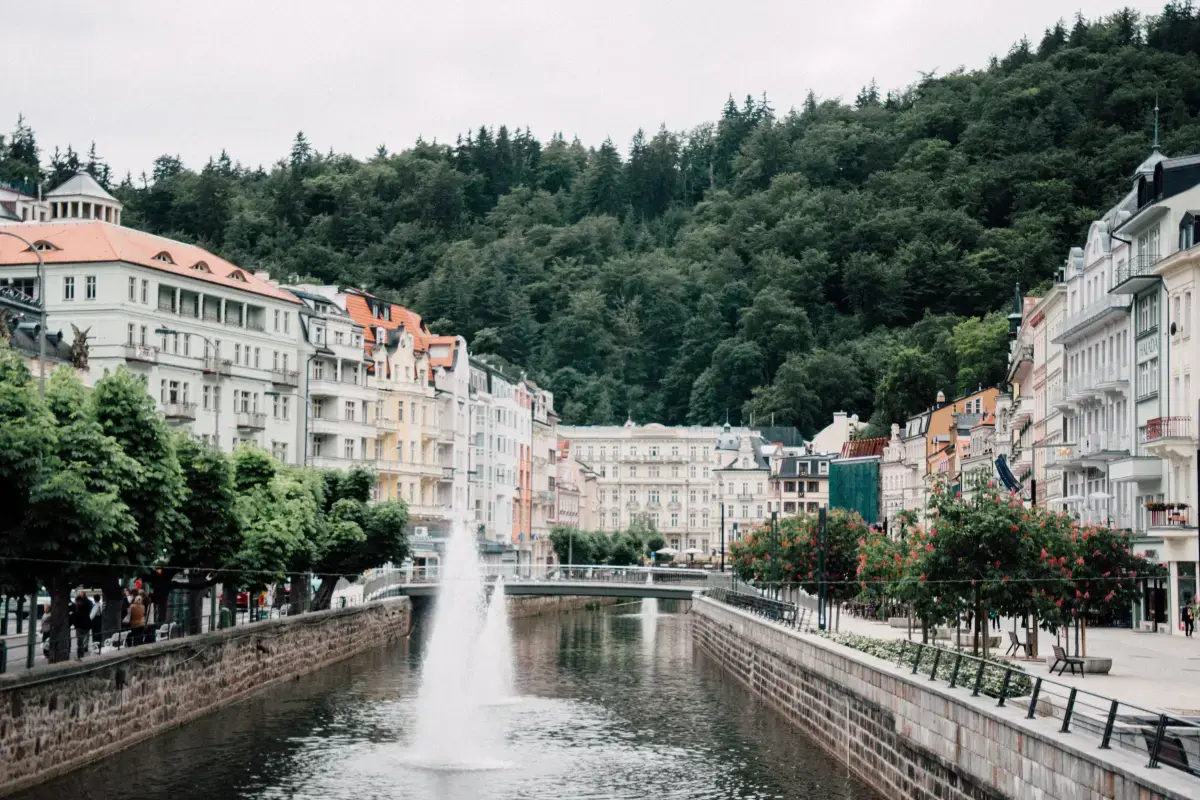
[12,602,876,800]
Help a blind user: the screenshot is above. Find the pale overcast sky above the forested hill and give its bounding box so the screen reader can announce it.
[0,0,1163,175]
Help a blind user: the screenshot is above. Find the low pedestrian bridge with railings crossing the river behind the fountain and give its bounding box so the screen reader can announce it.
[362,565,710,600]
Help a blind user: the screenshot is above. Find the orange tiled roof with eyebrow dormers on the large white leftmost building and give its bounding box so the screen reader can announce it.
[0,219,300,303]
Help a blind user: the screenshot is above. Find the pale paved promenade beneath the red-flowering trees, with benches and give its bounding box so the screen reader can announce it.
[840,612,1200,716]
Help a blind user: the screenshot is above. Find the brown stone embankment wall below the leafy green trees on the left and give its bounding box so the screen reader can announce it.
[0,597,412,798]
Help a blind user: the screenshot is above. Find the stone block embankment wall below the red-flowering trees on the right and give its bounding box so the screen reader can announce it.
[692,599,1200,800]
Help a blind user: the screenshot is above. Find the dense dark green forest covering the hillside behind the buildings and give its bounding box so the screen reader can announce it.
[7,1,1200,433]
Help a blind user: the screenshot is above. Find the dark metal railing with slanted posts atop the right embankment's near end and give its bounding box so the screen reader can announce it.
[896,639,1200,776]
